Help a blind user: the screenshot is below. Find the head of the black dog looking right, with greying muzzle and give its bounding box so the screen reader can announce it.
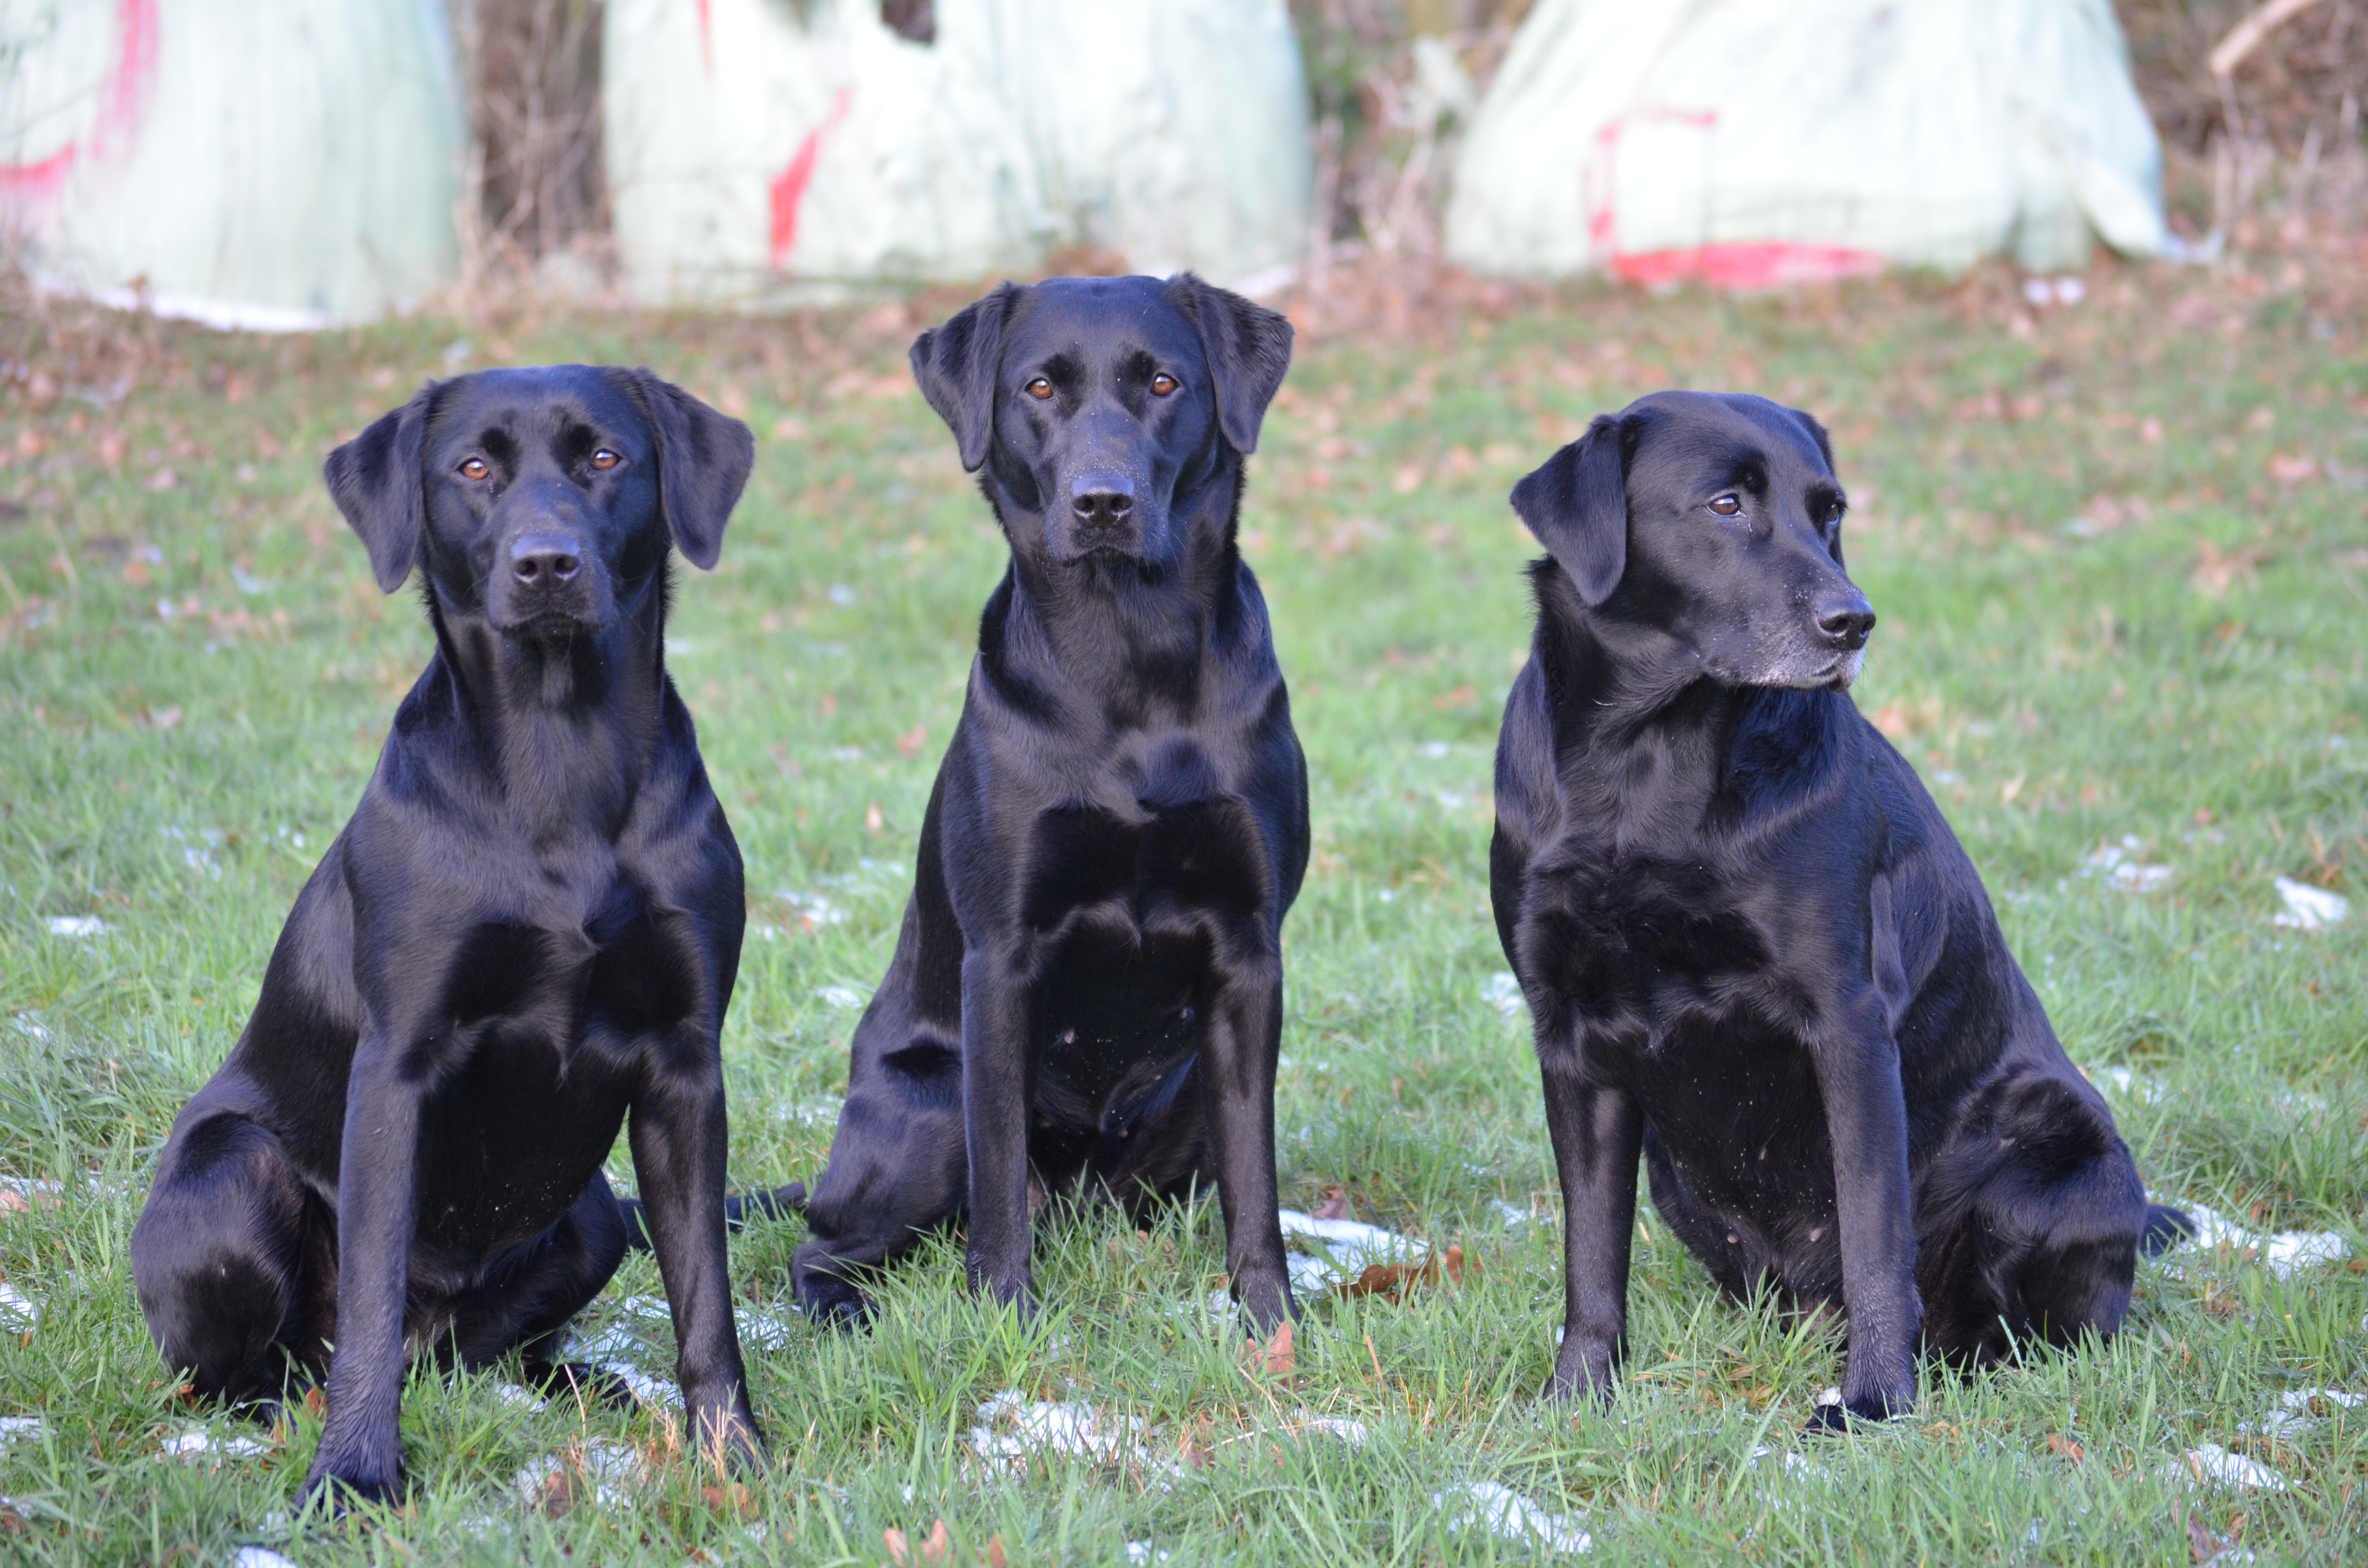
[1513,391,1875,689]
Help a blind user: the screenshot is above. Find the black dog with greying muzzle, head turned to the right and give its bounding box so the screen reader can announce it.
[1490,393,2186,1423]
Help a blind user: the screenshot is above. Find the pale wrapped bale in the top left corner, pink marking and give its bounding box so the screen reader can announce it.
[0,0,459,327]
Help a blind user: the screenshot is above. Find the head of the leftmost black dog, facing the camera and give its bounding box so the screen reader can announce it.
[322,365,755,639]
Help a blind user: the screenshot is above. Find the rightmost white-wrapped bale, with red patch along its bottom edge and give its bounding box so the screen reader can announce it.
[1447,0,2169,287]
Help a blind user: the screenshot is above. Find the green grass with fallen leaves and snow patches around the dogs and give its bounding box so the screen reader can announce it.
[0,270,2368,1566]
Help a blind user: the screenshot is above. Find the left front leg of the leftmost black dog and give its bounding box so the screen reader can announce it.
[303,1030,426,1509]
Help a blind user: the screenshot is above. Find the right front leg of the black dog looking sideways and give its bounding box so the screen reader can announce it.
[1814,1002,1923,1423]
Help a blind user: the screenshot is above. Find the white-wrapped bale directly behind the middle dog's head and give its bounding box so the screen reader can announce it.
[602,0,1312,303]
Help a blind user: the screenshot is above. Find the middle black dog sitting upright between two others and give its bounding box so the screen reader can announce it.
[793,275,1307,1326]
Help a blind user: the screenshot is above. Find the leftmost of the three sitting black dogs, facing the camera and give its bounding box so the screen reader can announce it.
[133,365,758,1499]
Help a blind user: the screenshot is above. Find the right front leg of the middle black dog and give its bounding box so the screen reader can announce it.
[1203,931,1298,1334]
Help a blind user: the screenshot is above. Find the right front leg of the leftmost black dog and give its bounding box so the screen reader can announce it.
[628,1056,758,1469]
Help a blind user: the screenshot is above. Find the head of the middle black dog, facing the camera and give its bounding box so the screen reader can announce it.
[912,272,1291,566]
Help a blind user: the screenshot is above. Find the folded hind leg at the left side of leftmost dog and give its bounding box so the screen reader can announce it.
[130,1113,324,1405]
